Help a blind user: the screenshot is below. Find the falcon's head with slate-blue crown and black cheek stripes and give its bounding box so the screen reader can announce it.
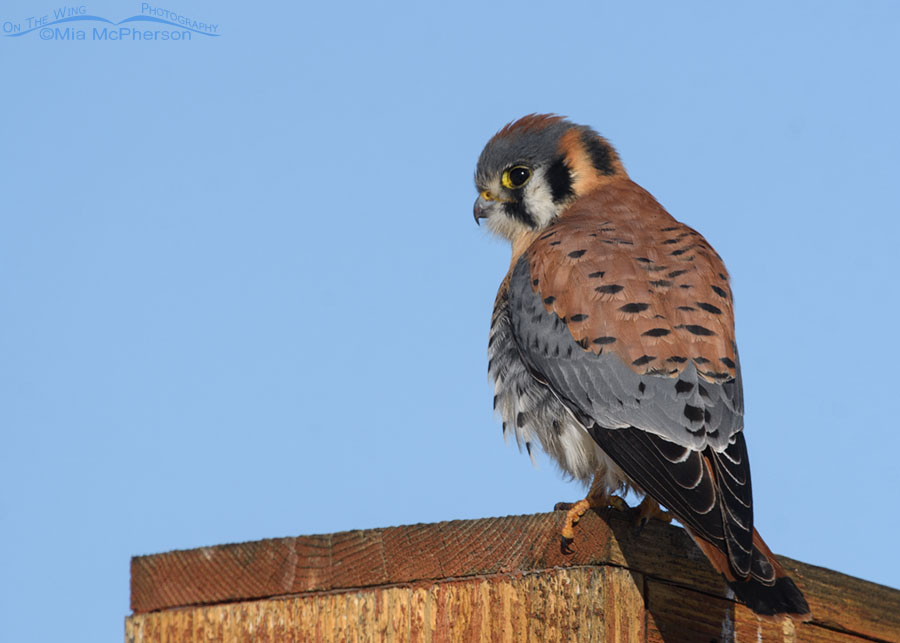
[474,114,627,241]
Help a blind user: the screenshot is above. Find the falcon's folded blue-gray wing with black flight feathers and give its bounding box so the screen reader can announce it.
[509,256,753,574]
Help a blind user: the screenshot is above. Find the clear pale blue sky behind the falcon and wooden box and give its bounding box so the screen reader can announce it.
[0,0,900,643]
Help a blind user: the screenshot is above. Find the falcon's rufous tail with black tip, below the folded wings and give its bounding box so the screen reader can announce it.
[688,529,812,621]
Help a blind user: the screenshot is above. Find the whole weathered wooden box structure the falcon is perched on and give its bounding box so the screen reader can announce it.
[125,512,900,643]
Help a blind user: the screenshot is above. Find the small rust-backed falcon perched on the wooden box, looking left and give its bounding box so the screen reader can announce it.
[475,115,809,618]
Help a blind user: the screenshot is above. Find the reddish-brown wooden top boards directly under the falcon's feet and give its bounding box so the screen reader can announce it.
[131,511,900,641]
